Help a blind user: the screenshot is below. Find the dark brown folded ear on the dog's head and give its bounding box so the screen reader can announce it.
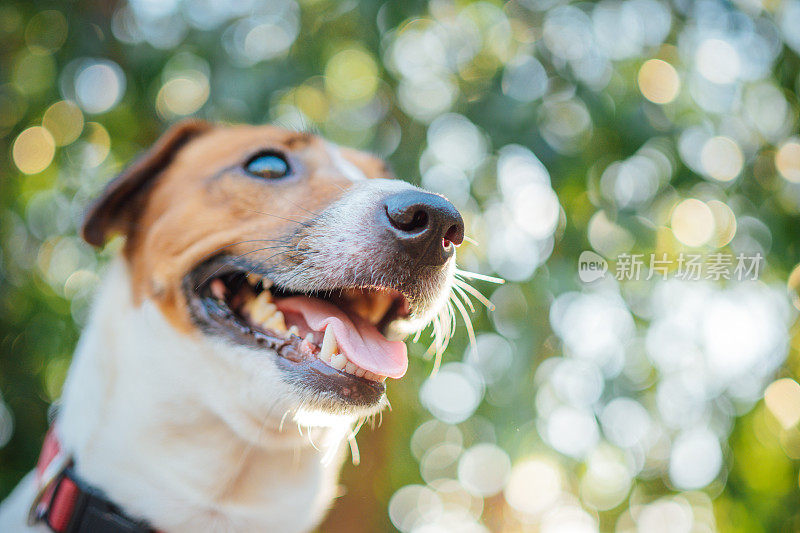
[81,119,213,246]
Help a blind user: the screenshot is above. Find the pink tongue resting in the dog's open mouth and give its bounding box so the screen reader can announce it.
[275,296,408,378]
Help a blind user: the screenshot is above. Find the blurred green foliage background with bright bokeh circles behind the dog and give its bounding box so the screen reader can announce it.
[0,0,800,532]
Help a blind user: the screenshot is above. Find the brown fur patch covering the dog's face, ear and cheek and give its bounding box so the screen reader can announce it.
[84,122,388,331]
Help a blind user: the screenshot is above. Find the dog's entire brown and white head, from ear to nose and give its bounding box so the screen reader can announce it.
[83,121,464,414]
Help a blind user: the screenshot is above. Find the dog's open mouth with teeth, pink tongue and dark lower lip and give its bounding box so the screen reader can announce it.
[184,257,411,404]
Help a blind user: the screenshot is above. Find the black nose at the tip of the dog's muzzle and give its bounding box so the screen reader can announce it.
[384,190,464,265]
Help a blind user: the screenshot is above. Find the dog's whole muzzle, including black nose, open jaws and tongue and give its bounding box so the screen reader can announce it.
[185,179,464,409]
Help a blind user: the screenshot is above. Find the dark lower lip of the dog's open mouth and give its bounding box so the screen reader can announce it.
[184,257,410,406]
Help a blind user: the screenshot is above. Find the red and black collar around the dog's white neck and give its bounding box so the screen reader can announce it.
[28,426,156,533]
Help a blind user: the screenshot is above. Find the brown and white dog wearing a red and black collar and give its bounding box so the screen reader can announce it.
[0,120,464,533]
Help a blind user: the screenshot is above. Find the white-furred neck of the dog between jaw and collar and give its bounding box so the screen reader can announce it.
[58,260,351,531]
